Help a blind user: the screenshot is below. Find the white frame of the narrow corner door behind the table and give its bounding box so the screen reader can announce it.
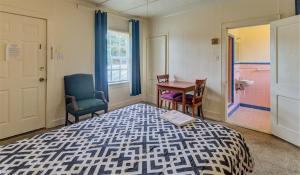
[146,33,169,102]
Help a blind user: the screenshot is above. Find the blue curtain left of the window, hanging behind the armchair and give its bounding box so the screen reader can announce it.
[95,11,109,100]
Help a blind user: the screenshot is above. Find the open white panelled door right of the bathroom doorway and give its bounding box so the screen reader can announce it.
[271,16,300,146]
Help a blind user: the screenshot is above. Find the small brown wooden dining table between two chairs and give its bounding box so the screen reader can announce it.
[156,81,195,113]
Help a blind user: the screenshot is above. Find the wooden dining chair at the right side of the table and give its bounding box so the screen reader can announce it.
[174,79,207,119]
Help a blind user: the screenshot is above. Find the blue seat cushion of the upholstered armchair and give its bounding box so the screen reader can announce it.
[67,98,107,116]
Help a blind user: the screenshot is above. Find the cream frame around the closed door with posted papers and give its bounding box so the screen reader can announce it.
[0,10,48,128]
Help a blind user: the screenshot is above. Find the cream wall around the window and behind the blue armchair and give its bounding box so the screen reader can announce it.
[0,0,147,127]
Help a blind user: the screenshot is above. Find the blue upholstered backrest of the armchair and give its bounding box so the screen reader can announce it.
[64,74,95,100]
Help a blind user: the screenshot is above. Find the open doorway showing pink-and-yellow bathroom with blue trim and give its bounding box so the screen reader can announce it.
[227,24,271,133]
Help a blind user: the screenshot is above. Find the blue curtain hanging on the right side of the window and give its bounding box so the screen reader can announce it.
[130,20,142,96]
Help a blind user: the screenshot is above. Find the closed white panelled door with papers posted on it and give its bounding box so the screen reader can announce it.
[0,12,46,139]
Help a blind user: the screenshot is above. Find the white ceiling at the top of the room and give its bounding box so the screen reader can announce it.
[86,0,207,17]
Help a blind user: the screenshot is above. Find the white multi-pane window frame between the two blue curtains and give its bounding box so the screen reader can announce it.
[107,29,130,85]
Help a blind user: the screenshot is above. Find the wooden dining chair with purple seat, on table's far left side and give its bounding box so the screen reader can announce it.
[157,74,181,109]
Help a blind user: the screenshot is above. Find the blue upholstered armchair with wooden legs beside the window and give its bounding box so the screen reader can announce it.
[64,74,108,126]
